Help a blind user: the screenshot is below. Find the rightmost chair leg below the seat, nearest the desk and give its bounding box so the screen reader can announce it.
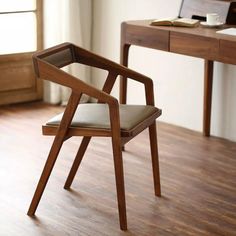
[149,122,161,197]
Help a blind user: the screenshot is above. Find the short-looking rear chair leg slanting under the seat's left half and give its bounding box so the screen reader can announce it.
[64,137,91,189]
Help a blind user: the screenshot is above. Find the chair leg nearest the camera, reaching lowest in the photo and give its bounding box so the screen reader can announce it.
[112,138,127,230]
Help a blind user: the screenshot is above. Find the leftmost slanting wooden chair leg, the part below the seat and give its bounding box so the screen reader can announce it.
[27,137,63,216]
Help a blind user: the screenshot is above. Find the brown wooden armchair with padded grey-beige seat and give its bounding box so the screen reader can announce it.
[28,43,161,230]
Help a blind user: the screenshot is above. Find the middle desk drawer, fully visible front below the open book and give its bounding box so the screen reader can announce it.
[170,32,219,60]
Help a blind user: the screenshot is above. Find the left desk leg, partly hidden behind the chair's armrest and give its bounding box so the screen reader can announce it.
[120,43,130,104]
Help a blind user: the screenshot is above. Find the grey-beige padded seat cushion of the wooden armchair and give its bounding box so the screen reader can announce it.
[46,103,161,130]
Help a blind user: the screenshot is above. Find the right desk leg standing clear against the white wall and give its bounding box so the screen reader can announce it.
[203,60,214,137]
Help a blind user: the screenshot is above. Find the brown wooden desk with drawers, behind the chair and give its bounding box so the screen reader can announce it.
[120,20,236,136]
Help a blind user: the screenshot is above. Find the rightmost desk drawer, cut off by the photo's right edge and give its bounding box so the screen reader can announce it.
[219,40,236,64]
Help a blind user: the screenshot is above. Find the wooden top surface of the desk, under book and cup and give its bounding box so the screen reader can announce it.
[123,20,236,42]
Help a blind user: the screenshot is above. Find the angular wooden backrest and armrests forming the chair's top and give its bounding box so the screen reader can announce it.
[33,43,154,105]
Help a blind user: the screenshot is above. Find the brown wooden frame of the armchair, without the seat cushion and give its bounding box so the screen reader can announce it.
[27,43,161,230]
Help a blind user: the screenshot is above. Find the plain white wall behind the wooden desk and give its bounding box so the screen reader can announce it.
[92,0,236,141]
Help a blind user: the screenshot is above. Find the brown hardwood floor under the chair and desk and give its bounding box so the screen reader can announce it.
[0,103,236,236]
